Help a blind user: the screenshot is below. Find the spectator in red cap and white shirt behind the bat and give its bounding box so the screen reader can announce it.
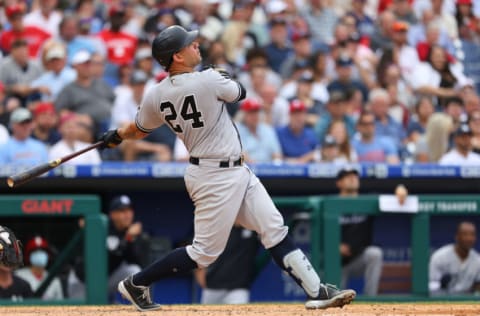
[48,112,102,165]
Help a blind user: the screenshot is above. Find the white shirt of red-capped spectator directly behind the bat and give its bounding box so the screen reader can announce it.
[48,140,102,165]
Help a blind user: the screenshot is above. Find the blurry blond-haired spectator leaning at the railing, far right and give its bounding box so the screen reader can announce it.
[415,113,454,163]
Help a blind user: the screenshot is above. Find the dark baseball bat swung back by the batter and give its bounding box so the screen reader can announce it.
[7,141,103,188]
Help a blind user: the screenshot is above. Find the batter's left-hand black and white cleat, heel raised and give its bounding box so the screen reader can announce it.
[118,276,162,312]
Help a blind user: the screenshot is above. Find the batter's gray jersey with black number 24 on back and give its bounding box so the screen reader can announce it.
[135,69,242,159]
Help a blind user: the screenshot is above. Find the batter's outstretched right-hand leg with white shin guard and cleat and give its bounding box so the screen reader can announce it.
[237,170,355,308]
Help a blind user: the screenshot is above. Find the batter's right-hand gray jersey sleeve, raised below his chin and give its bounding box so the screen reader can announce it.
[205,69,242,102]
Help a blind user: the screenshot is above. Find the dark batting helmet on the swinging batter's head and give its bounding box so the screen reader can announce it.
[152,25,198,70]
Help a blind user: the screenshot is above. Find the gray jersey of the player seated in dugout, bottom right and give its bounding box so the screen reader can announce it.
[429,244,480,294]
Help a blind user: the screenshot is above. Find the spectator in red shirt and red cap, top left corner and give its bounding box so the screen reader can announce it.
[0,3,50,59]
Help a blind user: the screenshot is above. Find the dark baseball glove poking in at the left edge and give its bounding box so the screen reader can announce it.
[0,226,23,268]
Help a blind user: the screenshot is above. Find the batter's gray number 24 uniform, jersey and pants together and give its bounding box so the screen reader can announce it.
[135,69,288,267]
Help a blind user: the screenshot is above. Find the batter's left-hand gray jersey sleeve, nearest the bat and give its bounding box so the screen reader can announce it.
[135,89,163,133]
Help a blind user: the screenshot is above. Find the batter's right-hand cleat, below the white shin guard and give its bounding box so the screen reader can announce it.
[305,284,357,309]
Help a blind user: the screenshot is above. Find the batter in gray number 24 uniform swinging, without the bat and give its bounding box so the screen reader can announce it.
[101,26,356,311]
